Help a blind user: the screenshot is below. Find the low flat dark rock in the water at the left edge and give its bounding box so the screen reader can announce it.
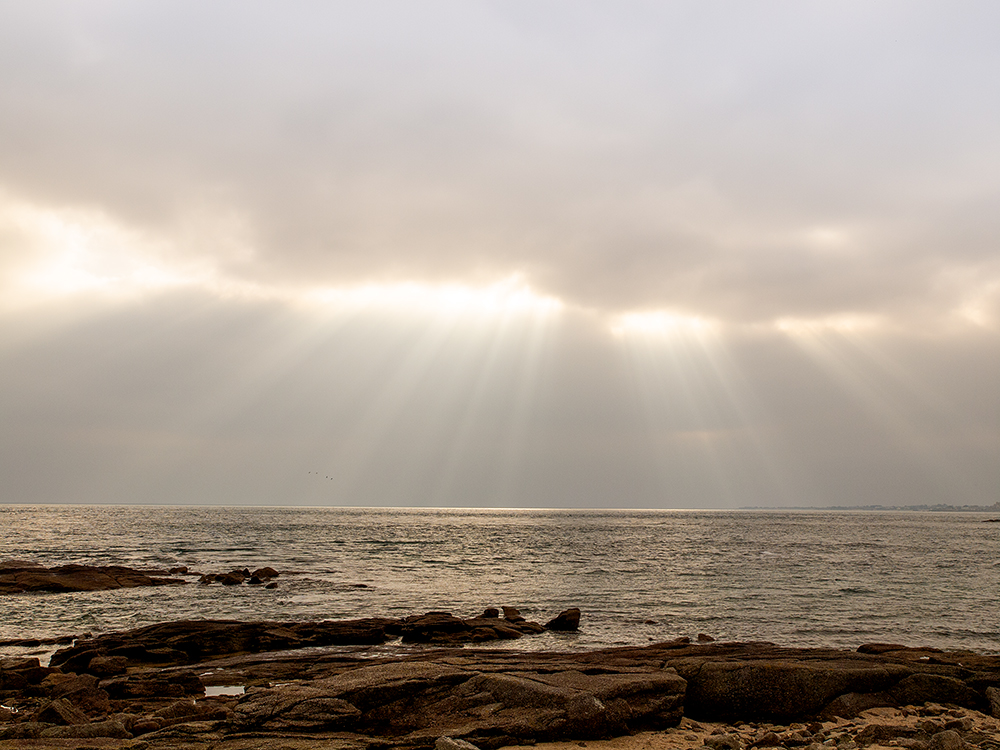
[0,565,186,594]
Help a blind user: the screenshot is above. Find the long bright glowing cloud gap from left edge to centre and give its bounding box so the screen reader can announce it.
[0,195,562,318]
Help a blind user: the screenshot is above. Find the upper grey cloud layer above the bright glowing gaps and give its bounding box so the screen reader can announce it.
[0,3,1000,321]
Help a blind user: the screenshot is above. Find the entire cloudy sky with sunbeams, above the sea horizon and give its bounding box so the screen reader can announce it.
[0,0,1000,508]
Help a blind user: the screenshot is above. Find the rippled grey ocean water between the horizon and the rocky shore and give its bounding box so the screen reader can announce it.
[0,505,1000,653]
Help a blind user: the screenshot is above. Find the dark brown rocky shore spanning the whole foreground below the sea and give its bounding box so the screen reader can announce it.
[0,608,1000,750]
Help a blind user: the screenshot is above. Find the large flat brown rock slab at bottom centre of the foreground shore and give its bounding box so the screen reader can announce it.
[233,661,685,748]
